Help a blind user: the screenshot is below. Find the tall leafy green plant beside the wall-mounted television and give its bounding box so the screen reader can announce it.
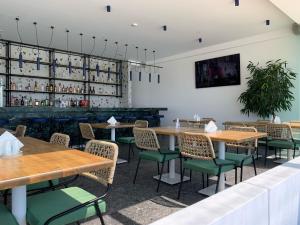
[238,59,296,120]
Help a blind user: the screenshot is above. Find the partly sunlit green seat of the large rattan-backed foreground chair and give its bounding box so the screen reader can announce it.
[27,187,106,225]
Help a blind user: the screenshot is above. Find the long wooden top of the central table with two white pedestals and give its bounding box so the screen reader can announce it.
[151,127,267,142]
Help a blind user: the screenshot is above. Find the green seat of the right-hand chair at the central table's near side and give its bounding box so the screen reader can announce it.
[182,159,235,176]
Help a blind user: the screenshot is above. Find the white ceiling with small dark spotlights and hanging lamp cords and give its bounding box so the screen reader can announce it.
[0,0,292,60]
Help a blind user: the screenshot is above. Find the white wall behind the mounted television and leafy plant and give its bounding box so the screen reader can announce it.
[132,29,300,125]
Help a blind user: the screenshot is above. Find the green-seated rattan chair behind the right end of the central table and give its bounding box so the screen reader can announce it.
[225,126,257,183]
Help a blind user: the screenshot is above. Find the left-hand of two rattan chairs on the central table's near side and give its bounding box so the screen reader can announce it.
[133,127,179,192]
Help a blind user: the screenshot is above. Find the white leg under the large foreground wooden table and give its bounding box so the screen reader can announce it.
[12,185,27,225]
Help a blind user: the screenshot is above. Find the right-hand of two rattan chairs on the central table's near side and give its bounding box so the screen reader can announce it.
[177,132,235,199]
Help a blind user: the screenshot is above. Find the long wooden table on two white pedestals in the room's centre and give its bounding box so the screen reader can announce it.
[152,127,267,195]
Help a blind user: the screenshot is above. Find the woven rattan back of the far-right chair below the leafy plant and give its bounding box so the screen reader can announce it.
[267,123,293,141]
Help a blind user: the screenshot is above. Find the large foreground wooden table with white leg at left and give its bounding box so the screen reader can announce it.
[0,137,113,225]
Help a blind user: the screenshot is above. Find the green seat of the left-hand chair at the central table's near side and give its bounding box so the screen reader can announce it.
[139,149,179,162]
